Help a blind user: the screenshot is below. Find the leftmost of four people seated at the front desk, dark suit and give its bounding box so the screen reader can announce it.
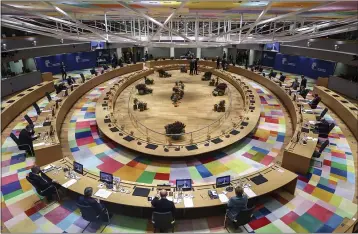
[29,166,59,201]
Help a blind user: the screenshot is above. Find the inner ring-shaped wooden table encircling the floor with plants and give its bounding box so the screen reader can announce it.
[96,65,261,157]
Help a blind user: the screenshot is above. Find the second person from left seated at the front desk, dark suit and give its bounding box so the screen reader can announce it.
[77,187,113,222]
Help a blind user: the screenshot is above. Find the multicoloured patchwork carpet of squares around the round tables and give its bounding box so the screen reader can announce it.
[1,69,357,233]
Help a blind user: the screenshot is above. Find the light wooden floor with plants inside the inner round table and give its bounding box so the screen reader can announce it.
[114,71,244,144]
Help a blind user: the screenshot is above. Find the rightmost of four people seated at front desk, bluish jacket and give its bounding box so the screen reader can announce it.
[226,186,248,220]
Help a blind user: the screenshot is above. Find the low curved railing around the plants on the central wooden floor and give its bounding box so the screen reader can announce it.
[128,76,232,145]
